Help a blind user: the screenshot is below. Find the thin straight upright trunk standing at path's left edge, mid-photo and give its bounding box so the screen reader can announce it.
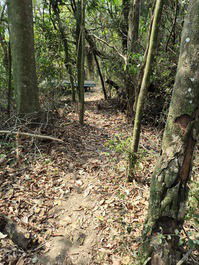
[77,0,85,124]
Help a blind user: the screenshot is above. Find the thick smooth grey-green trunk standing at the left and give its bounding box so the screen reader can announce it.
[7,0,39,114]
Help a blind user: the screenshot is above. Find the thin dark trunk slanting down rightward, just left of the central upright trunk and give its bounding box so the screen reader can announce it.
[52,4,75,102]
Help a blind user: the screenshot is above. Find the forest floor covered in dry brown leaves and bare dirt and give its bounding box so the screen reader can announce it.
[0,87,197,265]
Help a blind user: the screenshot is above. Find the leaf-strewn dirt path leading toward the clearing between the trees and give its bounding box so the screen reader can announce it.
[38,88,156,265]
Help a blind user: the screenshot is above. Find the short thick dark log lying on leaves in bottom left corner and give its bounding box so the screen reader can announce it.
[0,214,34,250]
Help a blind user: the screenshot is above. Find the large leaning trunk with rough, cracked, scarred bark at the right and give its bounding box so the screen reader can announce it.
[142,0,199,265]
